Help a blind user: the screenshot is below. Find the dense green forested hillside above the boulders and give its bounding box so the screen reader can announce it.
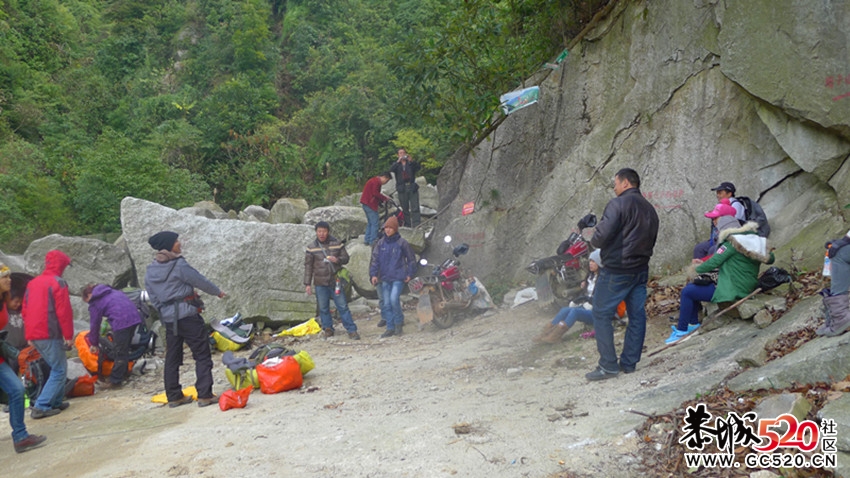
[0,0,603,251]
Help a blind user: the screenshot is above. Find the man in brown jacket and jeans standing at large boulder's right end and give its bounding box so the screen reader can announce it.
[304,221,360,340]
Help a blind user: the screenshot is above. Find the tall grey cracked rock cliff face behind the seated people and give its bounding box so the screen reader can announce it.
[435,0,850,281]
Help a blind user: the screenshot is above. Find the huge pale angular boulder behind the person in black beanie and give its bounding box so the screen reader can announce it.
[121,197,316,327]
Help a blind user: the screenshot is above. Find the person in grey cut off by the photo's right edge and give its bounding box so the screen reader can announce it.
[815,231,850,337]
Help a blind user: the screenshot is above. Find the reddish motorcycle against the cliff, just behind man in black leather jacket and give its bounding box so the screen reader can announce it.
[526,214,596,305]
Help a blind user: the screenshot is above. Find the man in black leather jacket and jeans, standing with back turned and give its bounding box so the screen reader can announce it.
[585,168,658,381]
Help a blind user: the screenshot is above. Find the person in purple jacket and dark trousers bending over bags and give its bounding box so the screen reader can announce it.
[83,284,142,389]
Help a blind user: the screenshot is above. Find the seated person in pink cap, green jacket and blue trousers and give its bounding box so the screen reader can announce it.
[664,202,774,345]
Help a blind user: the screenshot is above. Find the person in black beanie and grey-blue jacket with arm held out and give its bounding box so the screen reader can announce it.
[145,231,225,408]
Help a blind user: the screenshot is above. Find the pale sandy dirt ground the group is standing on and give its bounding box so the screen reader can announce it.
[0,303,693,478]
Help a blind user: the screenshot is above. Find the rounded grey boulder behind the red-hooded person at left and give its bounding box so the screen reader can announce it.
[24,234,135,295]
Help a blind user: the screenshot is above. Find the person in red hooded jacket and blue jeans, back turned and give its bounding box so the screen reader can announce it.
[21,250,74,418]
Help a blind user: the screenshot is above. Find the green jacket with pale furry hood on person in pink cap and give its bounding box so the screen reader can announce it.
[696,221,774,303]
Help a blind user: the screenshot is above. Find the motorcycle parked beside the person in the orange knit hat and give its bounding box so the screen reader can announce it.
[408,236,493,329]
